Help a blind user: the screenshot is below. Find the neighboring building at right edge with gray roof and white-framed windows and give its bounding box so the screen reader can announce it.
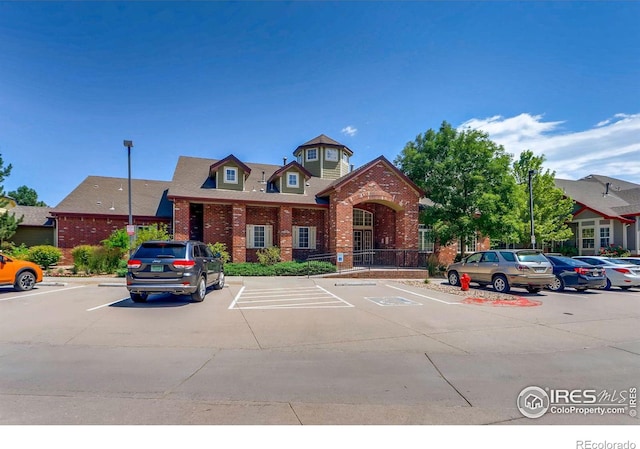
[555,175,640,255]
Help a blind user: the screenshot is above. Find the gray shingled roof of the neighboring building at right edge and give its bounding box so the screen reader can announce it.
[555,175,640,223]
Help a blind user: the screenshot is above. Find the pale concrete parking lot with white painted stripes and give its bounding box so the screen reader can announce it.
[0,278,640,425]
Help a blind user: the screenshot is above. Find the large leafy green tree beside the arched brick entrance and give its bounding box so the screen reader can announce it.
[394,122,521,255]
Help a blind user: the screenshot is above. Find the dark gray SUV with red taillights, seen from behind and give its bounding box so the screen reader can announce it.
[127,240,224,302]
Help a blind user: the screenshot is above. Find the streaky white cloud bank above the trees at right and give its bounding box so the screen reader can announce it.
[459,113,640,184]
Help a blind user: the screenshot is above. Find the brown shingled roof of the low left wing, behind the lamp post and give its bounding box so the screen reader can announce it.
[51,176,173,218]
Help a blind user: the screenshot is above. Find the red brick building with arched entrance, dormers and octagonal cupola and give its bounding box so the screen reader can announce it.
[51,135,424,264]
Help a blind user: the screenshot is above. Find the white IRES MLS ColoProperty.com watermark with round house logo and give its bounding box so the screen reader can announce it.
[517,386,638,419]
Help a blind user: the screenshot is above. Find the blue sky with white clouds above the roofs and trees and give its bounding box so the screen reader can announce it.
[0,1,640,206]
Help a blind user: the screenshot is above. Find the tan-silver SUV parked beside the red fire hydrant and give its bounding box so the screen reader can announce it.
[447,249,554,293]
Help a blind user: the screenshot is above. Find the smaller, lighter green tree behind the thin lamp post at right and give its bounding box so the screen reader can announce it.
[513,150,573,247]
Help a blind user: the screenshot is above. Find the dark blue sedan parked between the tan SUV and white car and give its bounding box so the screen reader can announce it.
[546,255,607,292]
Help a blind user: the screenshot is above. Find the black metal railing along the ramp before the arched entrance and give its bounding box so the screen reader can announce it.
[306,249,431,273]
